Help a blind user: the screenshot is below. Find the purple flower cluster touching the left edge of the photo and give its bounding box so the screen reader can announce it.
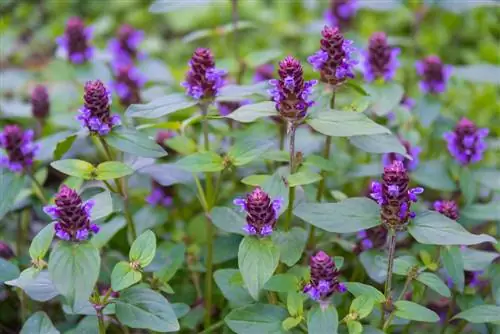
[0,125,39,172]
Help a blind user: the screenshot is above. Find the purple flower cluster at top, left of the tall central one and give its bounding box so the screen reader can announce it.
[182,48,226,100]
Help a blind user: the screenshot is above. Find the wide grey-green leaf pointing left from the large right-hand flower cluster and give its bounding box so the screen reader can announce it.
[293,197,380,233]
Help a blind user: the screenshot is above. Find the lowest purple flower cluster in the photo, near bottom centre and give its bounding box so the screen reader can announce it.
[303,251,346,303]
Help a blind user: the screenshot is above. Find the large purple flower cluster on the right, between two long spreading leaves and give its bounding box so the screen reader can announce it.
[370,160,424,230]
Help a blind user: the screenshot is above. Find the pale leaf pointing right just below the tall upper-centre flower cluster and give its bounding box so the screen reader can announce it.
[307,110,391,137]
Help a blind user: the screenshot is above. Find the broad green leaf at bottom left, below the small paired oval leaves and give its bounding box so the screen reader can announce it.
[115,287,180,332]
